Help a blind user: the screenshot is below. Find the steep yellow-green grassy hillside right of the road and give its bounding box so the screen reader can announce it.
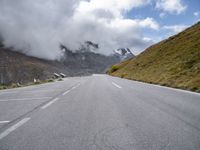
[108,22,200,92]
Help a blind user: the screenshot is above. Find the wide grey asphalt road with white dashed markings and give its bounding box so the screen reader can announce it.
[0,75,200,150]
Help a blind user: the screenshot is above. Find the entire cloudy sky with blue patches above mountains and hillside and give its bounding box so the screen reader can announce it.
[0,0,200,59]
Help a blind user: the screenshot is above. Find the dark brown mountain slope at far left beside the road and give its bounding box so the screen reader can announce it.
[0,47,65,84]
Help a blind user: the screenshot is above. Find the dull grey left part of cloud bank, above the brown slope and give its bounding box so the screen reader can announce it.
[0,0,78,59]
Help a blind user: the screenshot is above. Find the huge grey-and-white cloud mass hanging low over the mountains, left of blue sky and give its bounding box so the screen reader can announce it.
[0,0,159,60]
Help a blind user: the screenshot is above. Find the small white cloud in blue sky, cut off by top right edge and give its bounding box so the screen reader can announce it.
[156,0,187,14]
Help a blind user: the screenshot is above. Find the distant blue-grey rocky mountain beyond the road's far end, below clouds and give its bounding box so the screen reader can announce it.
[61,45,120,76]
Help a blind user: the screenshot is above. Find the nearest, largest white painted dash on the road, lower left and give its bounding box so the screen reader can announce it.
[0,118,31,140]
